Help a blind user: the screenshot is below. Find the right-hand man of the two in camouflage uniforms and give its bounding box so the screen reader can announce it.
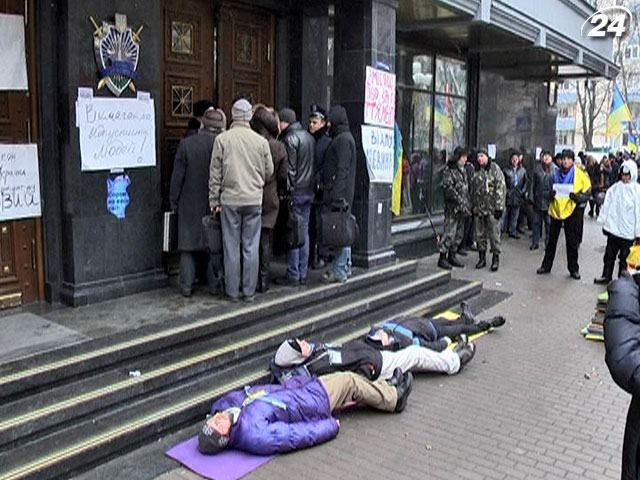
[470,148,506,272]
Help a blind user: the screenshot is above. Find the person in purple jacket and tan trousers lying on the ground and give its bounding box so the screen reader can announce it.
[198,369,413,455]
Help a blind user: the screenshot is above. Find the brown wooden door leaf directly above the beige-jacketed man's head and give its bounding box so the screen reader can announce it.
[218,2,275,116]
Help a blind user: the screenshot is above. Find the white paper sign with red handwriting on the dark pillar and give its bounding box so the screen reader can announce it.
[364,66,396,128]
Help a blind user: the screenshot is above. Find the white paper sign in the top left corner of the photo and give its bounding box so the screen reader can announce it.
[0,13,29,90]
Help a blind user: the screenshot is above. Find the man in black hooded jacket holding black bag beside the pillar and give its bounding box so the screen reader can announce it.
[322,105,356,283]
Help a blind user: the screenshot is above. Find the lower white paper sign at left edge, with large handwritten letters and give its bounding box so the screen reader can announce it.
[0,144,42,221]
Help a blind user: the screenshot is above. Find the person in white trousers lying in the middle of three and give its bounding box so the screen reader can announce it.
[271,338,476,380]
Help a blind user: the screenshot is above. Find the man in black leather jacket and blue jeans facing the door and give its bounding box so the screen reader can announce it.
[275,108,316,287]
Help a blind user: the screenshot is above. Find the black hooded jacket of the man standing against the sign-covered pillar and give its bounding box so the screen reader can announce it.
[322,105,356,209]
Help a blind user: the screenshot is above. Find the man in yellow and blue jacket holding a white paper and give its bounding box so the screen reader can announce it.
[537,150,591,280]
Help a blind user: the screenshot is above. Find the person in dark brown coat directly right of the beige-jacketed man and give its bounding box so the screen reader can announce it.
[249,107,287,293]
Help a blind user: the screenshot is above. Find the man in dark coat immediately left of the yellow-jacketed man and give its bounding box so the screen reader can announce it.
[529,151,556,250]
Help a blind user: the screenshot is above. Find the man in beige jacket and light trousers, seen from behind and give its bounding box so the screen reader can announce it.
[209,99,273,302]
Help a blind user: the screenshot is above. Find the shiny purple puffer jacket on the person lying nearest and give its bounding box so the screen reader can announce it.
[211,377,339,455]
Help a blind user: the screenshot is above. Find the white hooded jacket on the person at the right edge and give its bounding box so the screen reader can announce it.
[598,160,640,240]
